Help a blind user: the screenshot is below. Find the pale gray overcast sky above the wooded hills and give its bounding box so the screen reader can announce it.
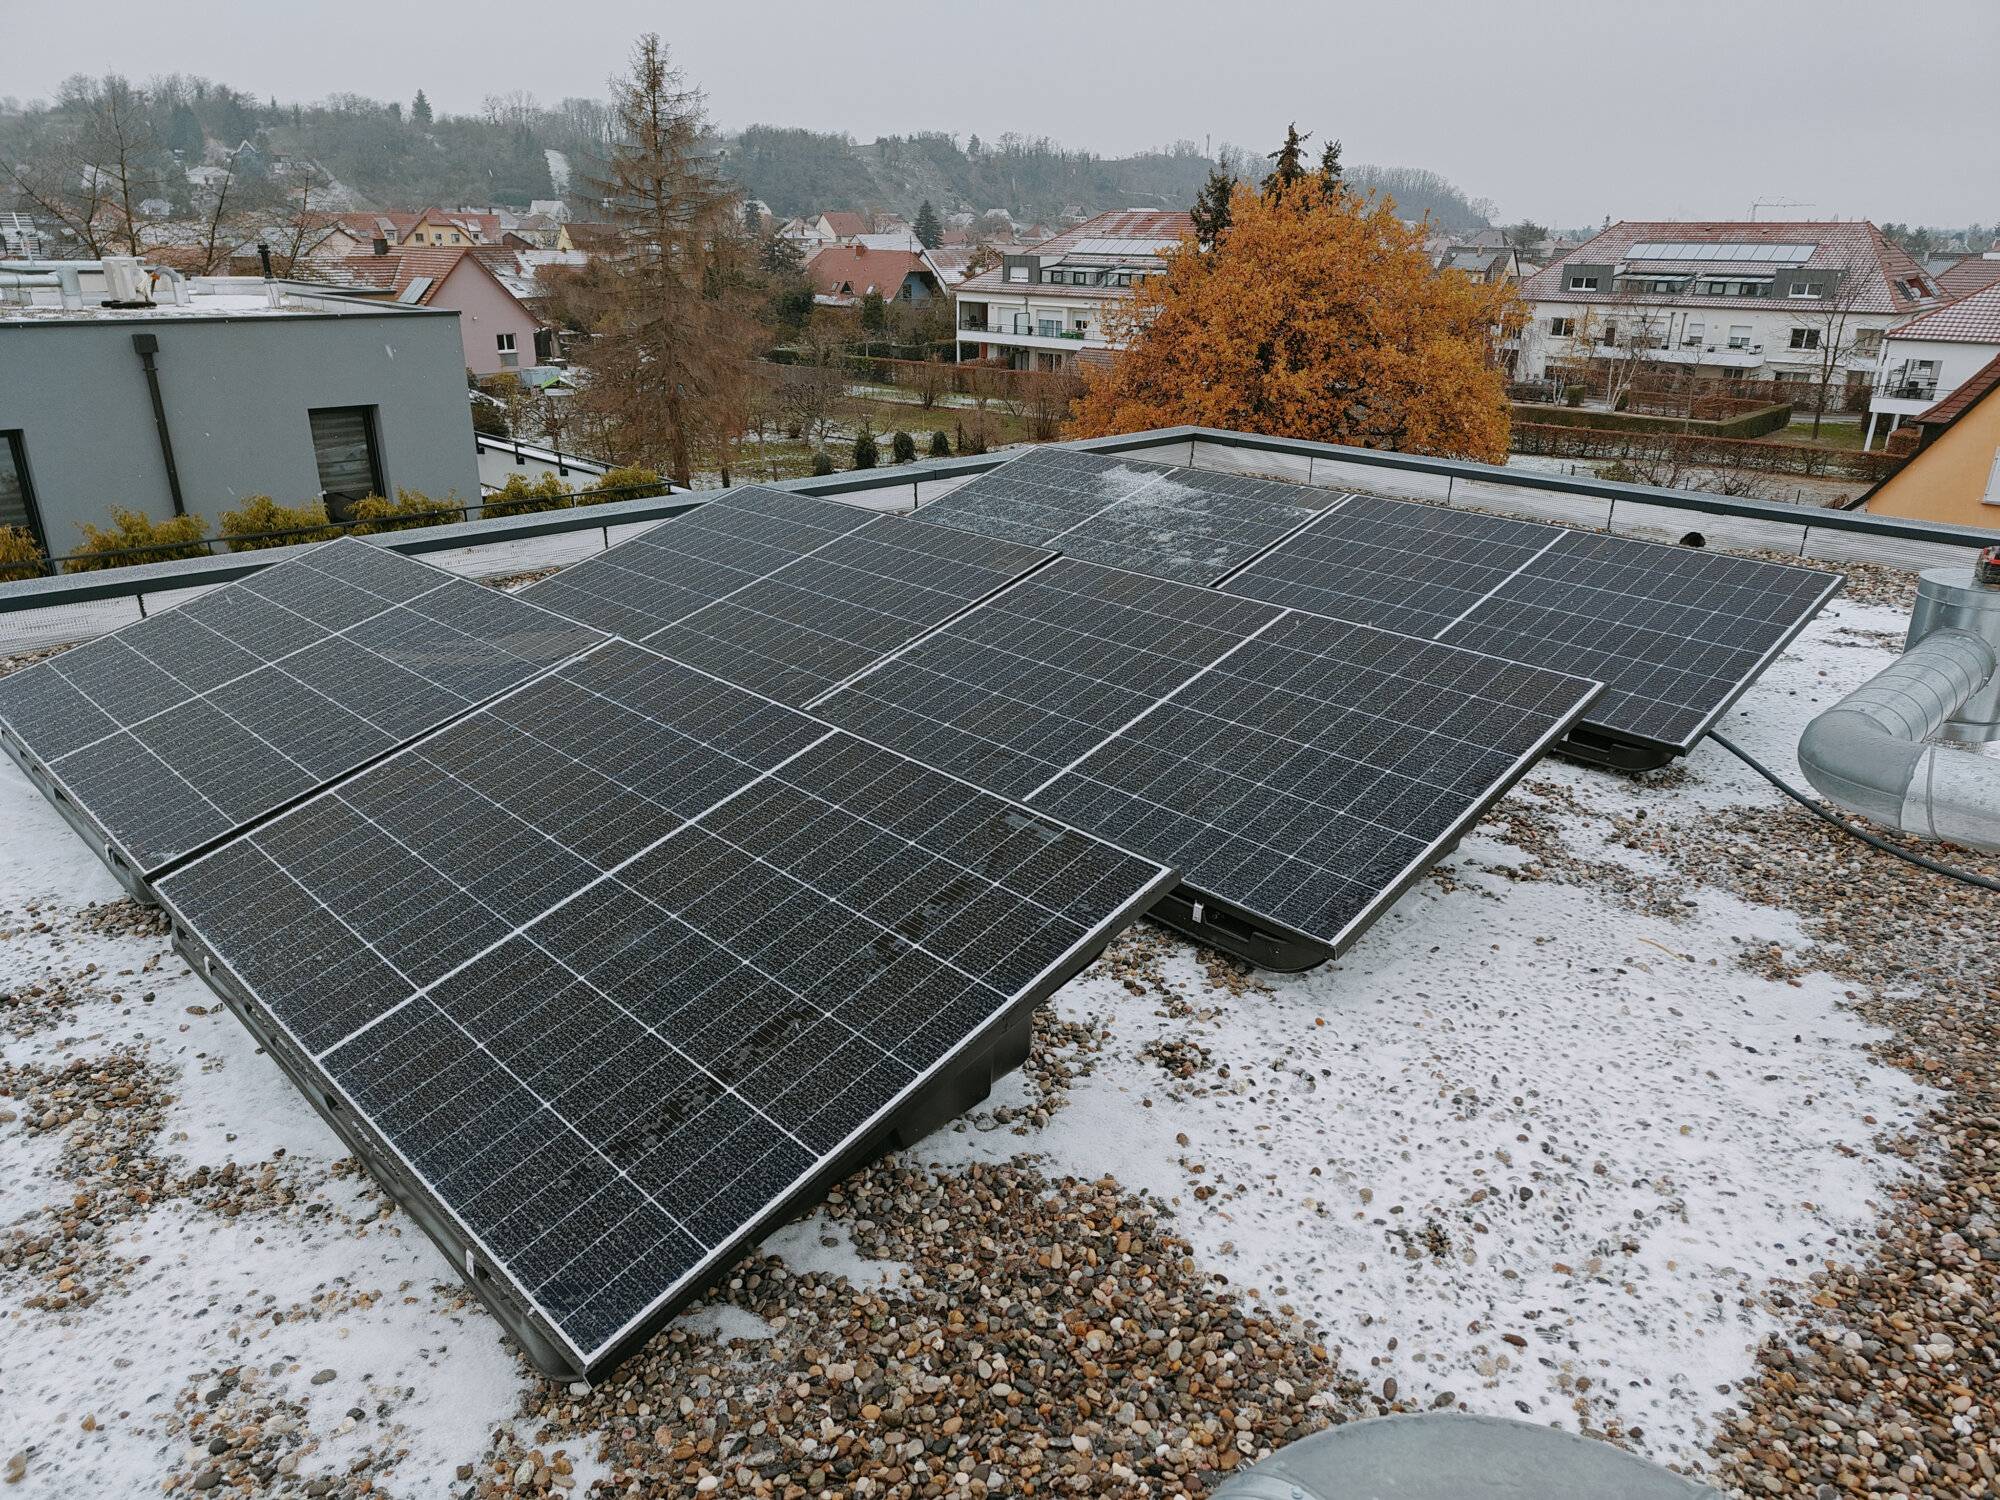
[0,0,2000,226]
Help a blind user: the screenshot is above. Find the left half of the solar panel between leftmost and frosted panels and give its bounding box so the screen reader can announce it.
[518,486,878,640]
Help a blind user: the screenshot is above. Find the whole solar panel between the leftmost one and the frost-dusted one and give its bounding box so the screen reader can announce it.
[522,490,1052,706]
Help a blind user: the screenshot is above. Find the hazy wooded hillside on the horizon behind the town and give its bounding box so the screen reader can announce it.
[0,74,1486,228]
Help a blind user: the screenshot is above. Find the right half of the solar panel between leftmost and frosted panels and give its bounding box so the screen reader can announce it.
[646,516,1050,706]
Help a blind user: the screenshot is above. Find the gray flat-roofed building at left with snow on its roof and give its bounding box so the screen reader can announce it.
[0,272,478,556]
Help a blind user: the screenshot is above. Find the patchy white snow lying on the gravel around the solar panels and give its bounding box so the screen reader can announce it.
[0,600,1926,1496]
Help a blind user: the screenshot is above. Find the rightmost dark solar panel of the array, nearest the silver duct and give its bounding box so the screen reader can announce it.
[1222,496,1842,770]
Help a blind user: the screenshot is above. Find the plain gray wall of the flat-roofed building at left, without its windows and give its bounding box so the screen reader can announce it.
[0,310,480,554]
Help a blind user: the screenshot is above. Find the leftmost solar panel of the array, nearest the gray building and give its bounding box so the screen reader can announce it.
[0,538,604,898]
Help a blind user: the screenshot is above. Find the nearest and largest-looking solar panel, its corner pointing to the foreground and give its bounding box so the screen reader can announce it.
[160,642,1174,1378]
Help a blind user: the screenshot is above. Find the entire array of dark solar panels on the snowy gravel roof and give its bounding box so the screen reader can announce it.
[0,438,1838,1372]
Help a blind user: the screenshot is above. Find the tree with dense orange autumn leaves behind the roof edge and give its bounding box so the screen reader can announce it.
[1068,172,1524,462]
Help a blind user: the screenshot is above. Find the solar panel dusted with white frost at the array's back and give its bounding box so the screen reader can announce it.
[916,448,1326,584]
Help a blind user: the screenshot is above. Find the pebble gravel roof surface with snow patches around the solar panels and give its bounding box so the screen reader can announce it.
[0,560,2000,1496]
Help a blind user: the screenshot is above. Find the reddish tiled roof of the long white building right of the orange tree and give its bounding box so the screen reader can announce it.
[1520,220,1936,312]
